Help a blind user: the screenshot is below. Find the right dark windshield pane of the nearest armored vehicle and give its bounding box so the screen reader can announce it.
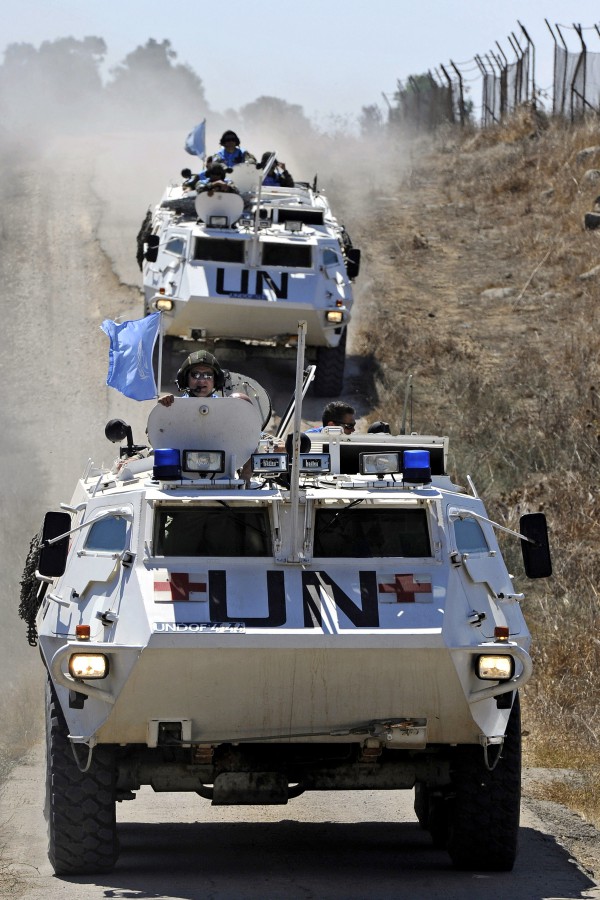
[313,507,431,559]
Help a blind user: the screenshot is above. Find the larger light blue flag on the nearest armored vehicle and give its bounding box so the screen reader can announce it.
[100,312,160,400]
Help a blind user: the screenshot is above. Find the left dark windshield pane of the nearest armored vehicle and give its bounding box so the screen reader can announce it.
[154,505,273,556]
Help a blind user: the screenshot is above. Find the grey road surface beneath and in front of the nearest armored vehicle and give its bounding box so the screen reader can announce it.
[0,745,600,900]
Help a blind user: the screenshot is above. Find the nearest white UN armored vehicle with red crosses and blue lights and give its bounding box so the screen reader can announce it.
[24,368,550,874]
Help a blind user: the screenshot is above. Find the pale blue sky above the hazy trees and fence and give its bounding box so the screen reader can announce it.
[0,0,600,125]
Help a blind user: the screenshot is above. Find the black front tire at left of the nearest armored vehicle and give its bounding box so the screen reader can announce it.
[45,681,119,875]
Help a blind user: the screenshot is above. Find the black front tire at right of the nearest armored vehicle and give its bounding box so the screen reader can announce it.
[446,696,521,872]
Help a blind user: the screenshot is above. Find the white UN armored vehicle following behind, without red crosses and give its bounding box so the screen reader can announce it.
[138,157,360,396]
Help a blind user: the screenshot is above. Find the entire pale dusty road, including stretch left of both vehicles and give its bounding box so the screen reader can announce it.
[0,132,600,900]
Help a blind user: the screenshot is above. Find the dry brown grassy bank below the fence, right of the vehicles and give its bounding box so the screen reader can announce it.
[355,110,600,824]
